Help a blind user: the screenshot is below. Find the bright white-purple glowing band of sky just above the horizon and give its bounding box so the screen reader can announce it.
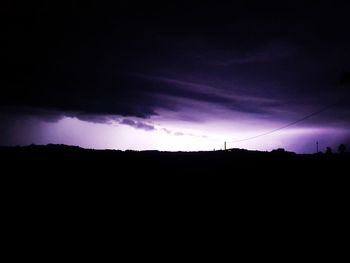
[0,106,350,153]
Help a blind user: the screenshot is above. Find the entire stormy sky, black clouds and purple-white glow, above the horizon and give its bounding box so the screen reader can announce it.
[0,0,350,153]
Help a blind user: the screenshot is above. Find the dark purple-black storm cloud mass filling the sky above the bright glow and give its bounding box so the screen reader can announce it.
[0,1,350,125]
